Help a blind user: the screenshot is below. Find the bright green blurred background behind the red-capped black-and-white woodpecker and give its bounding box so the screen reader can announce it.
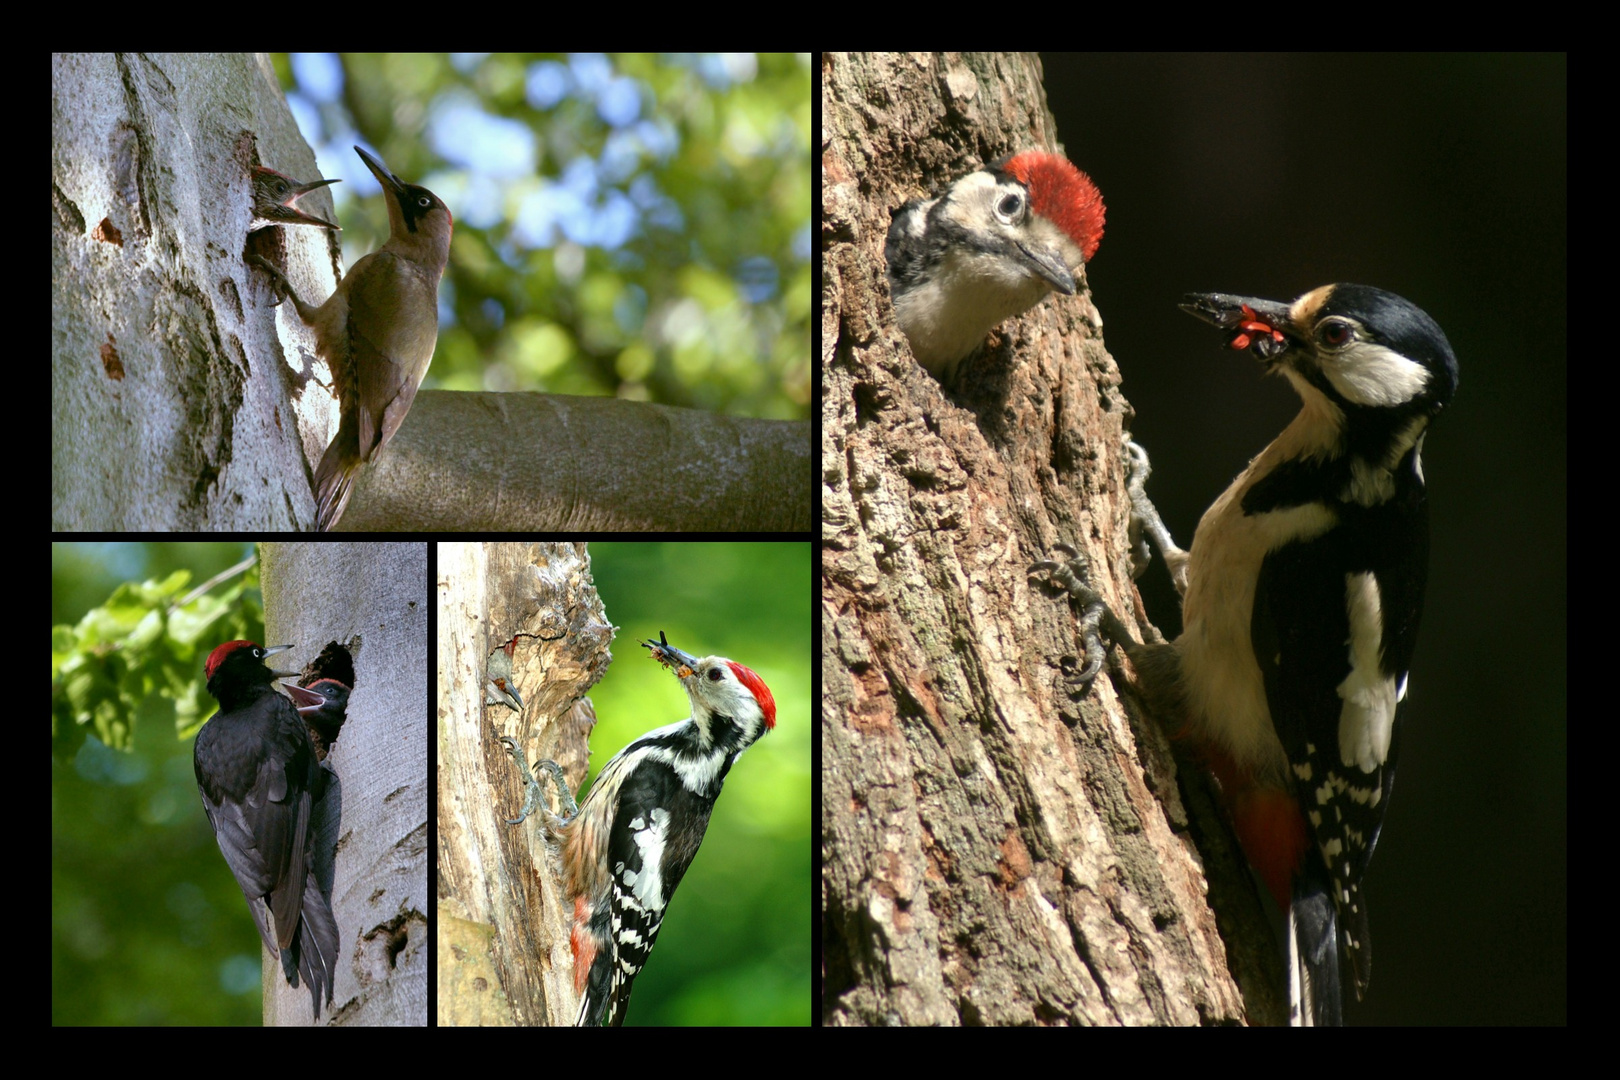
[590,542,812,1025]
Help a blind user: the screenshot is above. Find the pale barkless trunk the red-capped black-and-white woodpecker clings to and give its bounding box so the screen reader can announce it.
[437,544,612,1025]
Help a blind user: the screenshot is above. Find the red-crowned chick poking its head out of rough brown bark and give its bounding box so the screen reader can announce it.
[885,151,1103,379]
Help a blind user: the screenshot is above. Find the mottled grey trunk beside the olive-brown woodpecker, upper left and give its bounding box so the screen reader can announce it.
[50,53,339,531]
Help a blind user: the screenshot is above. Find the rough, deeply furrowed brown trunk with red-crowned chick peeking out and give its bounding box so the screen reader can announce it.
[821,53,1264,1025]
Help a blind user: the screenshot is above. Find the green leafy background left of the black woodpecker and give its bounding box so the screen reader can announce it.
[50,544,273,1025]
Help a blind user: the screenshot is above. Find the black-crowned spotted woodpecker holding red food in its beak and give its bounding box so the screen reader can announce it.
[1032,285,1458,1023]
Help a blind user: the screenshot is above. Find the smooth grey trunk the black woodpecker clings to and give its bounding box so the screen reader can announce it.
[261,542,433,1027]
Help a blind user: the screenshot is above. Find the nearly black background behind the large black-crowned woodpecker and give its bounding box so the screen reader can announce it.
[1042,53,1567,1023]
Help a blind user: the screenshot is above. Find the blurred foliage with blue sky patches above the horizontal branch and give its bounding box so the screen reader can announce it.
[275,53,812,419]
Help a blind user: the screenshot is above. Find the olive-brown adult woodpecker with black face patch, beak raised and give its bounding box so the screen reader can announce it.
[253,146,454,531]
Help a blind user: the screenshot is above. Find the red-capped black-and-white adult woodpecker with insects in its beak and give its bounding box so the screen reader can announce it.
[501,633,776,1027]
